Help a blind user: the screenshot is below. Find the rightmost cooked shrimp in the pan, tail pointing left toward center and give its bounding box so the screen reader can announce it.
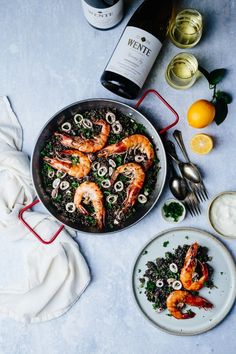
[98,134,155,169]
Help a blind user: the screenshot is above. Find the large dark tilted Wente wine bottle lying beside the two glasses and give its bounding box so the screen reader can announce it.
[101,0,173,99]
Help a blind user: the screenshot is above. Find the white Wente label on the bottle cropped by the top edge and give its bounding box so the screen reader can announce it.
[82,0,123,29]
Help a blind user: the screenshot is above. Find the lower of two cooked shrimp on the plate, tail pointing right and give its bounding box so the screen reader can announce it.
[166,290,213,320]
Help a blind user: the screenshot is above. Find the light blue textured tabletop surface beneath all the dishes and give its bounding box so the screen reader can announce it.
[0,0,236,354]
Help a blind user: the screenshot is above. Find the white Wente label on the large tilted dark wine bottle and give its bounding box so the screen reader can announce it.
[105,26,162,88]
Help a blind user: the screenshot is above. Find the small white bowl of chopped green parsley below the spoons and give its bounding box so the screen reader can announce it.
[161,199,186,223]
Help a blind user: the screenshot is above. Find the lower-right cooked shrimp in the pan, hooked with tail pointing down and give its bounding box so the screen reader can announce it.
[111,162,145,211]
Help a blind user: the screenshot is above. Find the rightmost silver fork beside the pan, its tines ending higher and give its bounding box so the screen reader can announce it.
[173,130,209,201]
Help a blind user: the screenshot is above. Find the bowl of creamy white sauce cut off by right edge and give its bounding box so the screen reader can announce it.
[210,193,236,237]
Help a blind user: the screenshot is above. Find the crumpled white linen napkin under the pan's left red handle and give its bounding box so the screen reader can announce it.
[0,97,90,322]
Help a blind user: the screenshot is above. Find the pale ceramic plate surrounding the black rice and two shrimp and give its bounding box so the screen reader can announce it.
[132,228,236,335]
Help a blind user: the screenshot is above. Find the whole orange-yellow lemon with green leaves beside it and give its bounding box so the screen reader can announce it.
[187,100,216,128]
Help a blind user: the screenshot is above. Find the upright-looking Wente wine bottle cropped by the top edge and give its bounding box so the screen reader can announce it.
[81,0,124,30]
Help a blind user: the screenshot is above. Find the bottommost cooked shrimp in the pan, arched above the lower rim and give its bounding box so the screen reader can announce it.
[74,182,105,229]
